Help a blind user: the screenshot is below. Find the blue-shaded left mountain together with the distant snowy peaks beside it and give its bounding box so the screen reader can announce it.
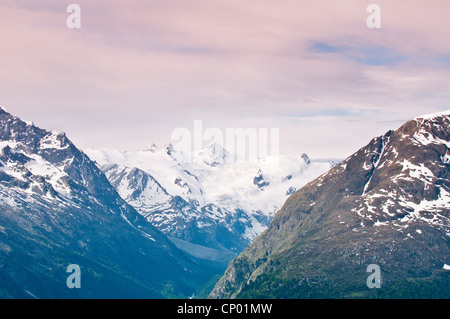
[0,108,332,298]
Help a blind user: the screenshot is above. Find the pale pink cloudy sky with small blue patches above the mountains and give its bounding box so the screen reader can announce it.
[0,0,450,158]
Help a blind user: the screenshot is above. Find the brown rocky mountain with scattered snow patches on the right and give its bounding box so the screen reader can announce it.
[210,112,450,298]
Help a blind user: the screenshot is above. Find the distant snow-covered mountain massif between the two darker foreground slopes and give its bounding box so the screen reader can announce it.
[85,142,332,256]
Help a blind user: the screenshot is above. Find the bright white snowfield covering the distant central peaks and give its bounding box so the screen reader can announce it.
[85,145,331,239]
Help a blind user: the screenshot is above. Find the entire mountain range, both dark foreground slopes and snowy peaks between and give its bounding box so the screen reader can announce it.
[0,108,450,298]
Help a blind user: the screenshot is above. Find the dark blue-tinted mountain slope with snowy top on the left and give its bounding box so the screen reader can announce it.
[0,108,219,298]
